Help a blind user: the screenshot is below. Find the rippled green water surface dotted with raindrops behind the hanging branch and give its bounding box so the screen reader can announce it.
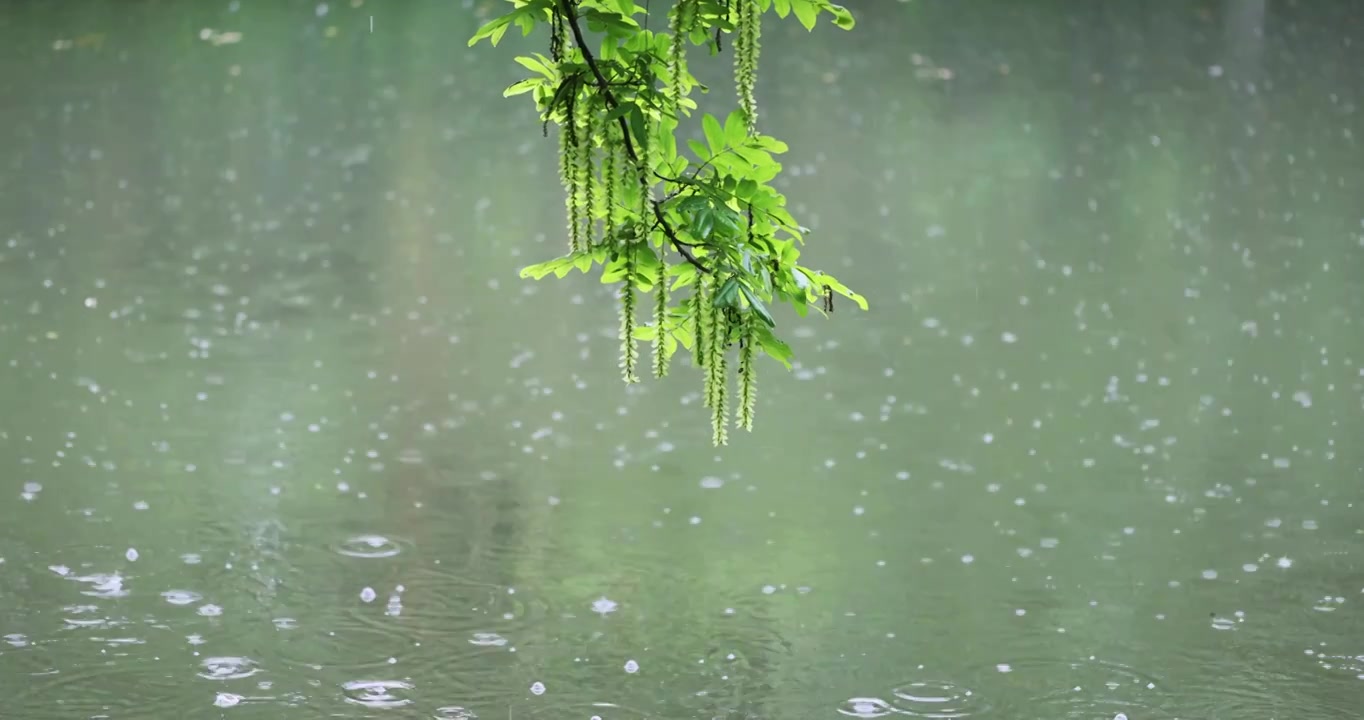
[0,0,1364,720]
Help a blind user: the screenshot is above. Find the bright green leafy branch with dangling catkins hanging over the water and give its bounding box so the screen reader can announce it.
[469,0,868,445]
